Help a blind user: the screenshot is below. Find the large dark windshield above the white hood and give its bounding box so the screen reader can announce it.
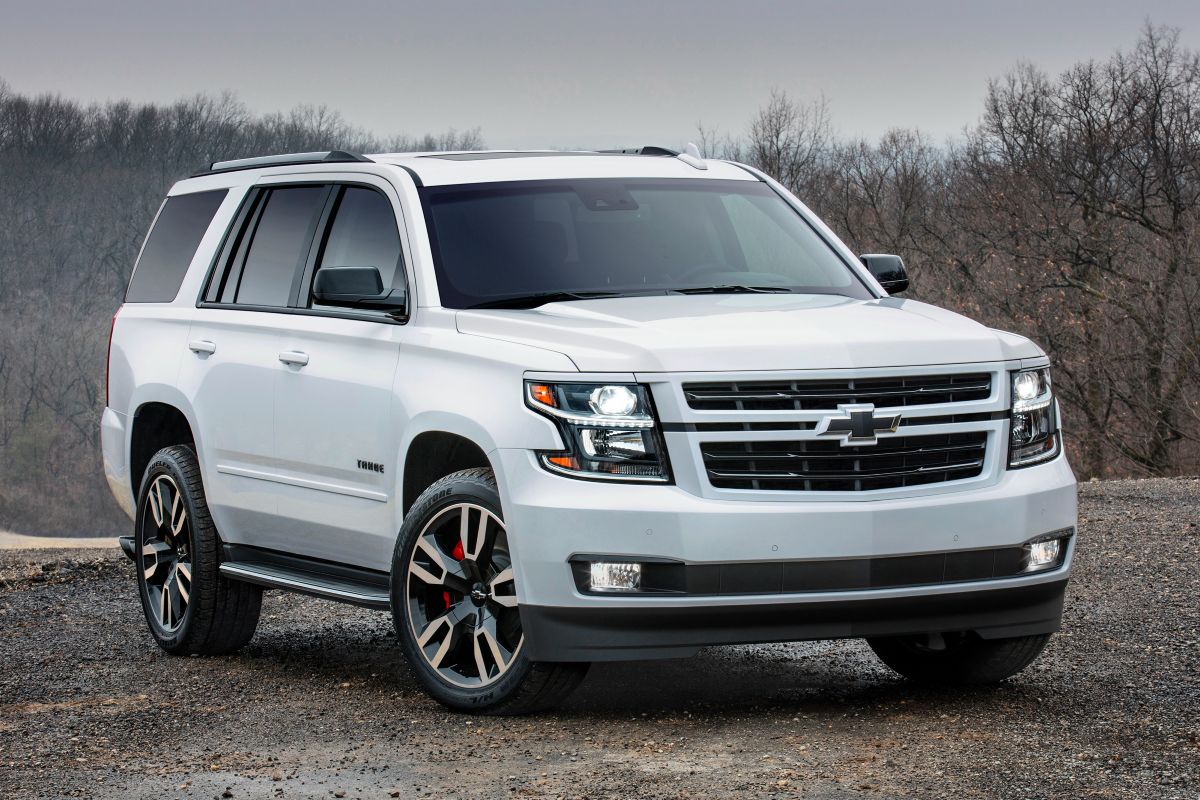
[421,179,874,308]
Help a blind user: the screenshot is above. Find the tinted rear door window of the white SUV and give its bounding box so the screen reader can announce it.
[235,186,325,306]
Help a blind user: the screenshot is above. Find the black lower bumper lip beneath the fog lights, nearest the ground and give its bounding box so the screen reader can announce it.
[521,578,1067,661]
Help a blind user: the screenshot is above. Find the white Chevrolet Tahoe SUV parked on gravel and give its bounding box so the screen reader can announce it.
[102,148,1076,714]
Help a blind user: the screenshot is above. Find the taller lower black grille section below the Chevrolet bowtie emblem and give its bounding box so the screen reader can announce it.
[700,431,988,492]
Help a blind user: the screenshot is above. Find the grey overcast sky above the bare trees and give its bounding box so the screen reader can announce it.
[0,0,1200,148]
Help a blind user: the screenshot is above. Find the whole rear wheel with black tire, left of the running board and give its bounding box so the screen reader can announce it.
[133,445,263,655]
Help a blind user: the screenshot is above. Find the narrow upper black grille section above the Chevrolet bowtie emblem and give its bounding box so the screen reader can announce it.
[683,373,991,411]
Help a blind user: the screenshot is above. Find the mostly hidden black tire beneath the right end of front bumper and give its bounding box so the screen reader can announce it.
[866,633,1050,686]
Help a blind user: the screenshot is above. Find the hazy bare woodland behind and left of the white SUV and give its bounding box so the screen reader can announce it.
[0,80,482,533]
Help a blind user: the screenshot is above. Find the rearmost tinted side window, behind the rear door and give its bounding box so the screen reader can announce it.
[125,190,228,302]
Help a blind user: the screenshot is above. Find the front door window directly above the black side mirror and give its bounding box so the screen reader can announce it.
[318,186,404,309]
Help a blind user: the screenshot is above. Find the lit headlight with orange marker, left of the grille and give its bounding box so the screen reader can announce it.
[526,380,671,483]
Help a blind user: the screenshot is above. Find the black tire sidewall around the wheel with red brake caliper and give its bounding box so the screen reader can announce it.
[391,473,533,711]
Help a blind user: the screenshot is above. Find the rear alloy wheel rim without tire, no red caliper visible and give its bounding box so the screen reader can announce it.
[140,475,192,631]
